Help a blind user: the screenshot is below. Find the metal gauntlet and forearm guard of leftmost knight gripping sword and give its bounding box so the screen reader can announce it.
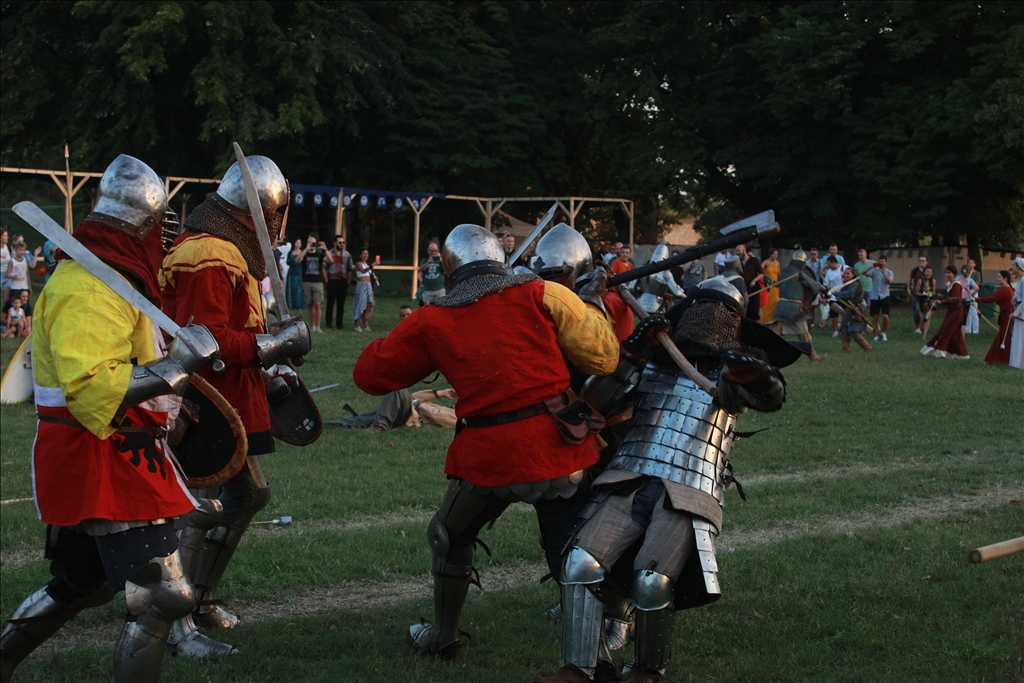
[121,325,223,408]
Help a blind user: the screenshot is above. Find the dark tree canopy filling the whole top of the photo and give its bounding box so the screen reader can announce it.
[0,0,1024,247]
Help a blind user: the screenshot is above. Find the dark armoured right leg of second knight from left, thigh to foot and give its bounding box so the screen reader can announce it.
[195,456,270,629]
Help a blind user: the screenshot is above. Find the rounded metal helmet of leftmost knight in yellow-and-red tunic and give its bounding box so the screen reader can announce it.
[92,155,167,235]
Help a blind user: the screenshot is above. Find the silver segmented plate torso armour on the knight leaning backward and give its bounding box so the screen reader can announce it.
[608,364,736,505]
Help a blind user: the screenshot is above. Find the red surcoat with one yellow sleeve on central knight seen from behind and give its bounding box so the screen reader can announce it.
[353,280,618,486]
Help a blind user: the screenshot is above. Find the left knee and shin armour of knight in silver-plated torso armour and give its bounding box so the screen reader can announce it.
[561,546,604,673]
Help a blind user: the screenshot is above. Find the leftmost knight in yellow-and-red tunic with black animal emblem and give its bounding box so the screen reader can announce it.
[0,155,218,683]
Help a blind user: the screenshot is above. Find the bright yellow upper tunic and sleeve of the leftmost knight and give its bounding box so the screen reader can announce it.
[36,263,149,438]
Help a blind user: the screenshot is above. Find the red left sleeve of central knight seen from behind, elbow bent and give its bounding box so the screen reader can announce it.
[352,308,435,396]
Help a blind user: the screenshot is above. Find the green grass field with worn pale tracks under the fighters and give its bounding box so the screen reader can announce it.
[0,299,1024,683]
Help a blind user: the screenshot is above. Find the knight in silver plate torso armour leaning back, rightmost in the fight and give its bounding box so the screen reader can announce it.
[536,276,800,683]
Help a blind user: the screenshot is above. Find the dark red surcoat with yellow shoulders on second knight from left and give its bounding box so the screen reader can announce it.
[160,232,273,448]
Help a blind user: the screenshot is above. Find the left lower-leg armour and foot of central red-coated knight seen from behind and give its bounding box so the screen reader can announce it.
[409,515,473,657]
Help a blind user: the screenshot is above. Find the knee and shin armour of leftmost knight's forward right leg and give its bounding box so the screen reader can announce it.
[114,551,196,683]
